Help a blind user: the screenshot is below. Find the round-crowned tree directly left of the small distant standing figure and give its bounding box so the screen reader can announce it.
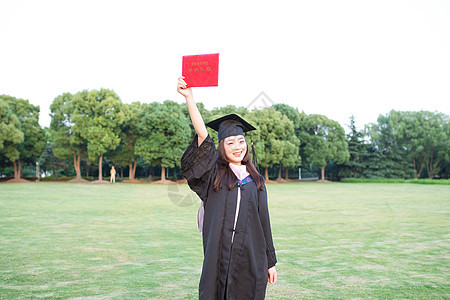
[72,89,126,181]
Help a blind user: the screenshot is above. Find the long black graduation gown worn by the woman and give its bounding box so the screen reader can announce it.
[181,135,277,300]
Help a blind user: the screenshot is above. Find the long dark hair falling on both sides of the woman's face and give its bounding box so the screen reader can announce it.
[213,139,264,192]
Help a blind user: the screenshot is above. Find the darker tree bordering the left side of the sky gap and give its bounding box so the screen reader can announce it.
[1,95,45,180]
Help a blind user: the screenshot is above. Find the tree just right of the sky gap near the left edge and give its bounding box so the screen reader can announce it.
[50,93,87,181]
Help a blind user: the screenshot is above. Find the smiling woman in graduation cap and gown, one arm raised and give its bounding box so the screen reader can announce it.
[178,77,277,300]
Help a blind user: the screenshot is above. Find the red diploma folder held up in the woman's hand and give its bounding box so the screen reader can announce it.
[182,53,219,87]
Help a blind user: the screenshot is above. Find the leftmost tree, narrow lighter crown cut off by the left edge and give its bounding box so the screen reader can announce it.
[0,95,24,178]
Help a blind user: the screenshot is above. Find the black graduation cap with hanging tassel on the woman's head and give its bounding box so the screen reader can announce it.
[205,114,259,170]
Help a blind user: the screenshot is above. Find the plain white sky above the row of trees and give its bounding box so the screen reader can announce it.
[0,0,450,128]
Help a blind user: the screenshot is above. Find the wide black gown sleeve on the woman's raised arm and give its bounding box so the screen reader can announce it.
[181,135,217,202]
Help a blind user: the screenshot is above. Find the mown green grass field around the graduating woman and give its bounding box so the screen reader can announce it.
[0,183,450,299]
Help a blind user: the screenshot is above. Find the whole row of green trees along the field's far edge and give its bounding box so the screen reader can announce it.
[0,89,450,181]
